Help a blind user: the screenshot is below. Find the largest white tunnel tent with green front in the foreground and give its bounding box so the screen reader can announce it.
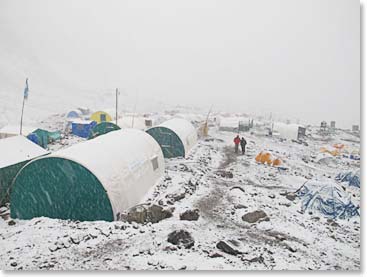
[10,129,164,221]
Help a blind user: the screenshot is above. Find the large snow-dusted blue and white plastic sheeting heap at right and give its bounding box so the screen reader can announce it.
[297,181,359,219]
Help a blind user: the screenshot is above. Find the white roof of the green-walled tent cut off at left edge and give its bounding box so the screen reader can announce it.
[0,136,48,168]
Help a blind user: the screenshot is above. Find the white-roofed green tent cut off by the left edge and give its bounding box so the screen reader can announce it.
[0,136,48,206]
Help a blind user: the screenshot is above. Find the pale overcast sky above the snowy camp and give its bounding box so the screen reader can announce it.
[0,0,360,128]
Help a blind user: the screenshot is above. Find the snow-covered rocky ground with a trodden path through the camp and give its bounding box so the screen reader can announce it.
[0,117,360,270]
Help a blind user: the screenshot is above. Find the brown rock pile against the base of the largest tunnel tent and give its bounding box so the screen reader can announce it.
[126,204,172,223]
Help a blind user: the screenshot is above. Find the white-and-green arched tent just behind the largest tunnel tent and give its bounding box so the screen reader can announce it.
[147,118,197,158]
